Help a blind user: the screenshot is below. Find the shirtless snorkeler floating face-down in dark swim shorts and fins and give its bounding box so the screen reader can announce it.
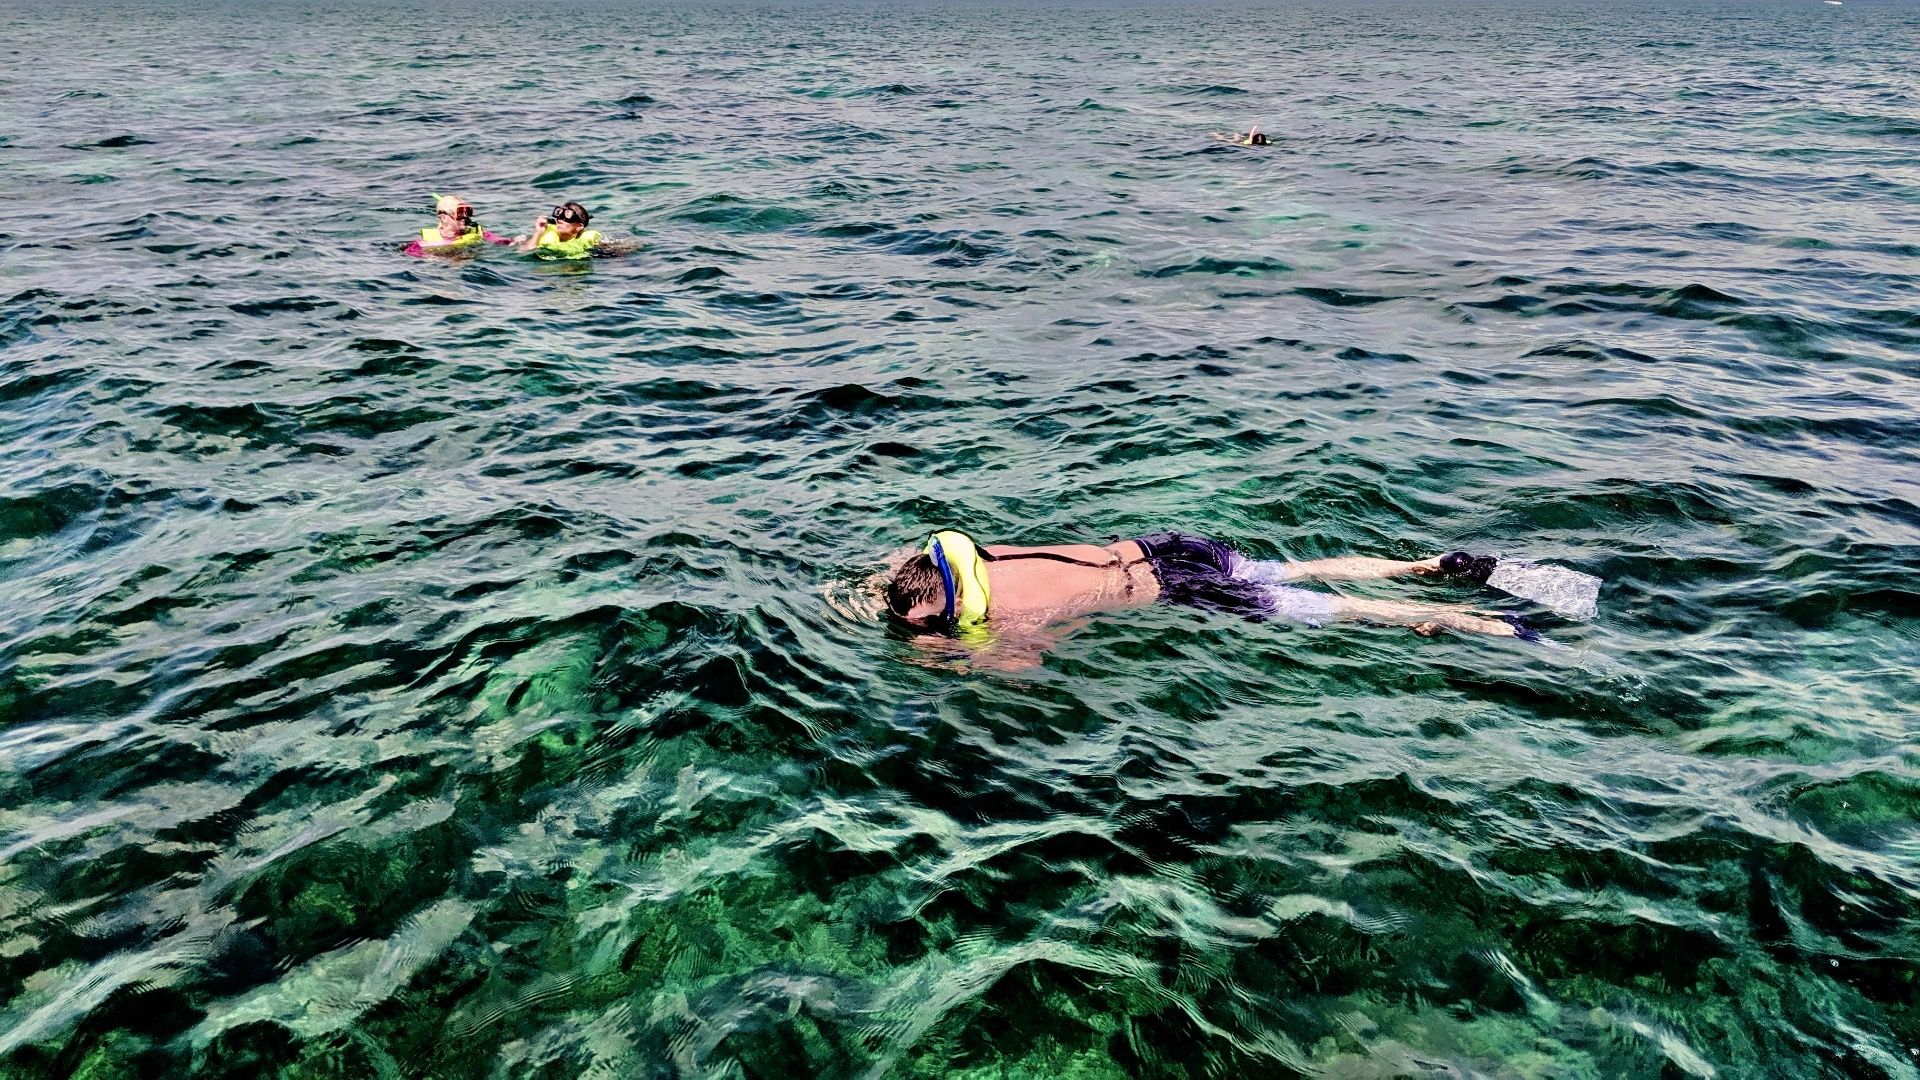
[874,528,1597,657]
